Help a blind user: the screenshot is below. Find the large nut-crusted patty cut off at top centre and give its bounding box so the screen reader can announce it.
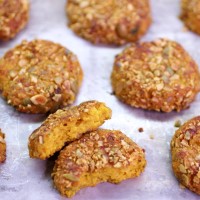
[66,0,151,45]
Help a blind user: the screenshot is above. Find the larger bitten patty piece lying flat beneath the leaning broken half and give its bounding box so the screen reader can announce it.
[52,129,146,197]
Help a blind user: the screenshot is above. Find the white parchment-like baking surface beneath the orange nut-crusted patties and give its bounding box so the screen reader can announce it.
[0,0,200,200]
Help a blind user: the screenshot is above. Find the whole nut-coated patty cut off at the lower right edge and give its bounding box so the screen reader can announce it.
[171,116,200,195]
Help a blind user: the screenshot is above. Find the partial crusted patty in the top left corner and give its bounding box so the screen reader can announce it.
[0,0,29,40]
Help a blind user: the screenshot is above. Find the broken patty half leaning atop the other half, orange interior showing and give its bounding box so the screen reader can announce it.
[29,101,112,160]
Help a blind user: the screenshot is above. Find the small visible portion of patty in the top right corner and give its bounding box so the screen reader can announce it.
[180,0,200,34]
